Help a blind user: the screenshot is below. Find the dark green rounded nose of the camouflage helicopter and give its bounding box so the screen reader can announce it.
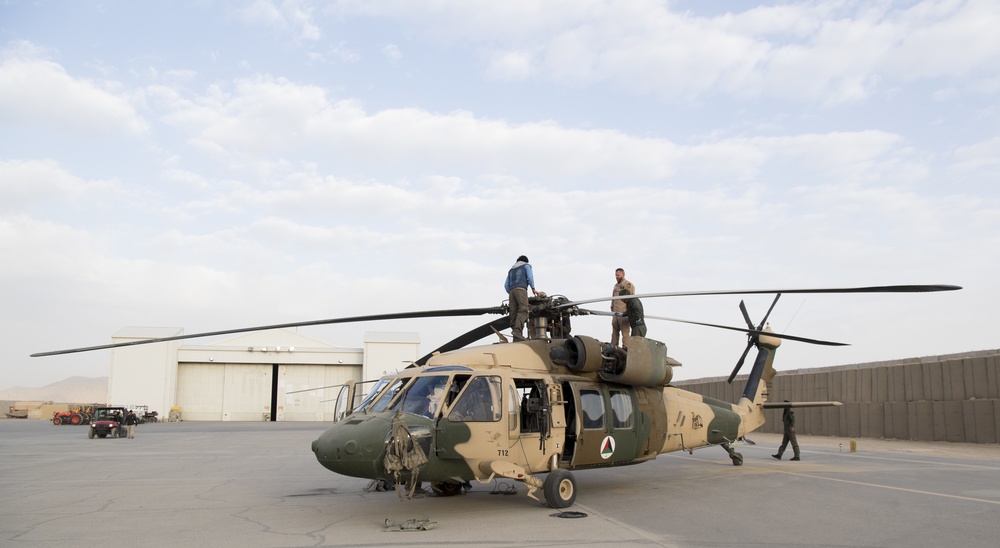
[312,416,392,478]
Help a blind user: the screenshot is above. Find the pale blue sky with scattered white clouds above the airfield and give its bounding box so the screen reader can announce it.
[0,0,1000,389]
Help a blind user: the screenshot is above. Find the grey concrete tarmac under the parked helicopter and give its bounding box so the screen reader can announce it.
[0,420,1000,548]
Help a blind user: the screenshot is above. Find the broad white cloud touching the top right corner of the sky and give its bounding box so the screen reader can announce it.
[339,0,1000,105]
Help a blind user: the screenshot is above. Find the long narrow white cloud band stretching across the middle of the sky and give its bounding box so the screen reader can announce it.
[146,77,926,191]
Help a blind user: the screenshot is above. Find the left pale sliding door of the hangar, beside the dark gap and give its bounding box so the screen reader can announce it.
[177,363,274,421]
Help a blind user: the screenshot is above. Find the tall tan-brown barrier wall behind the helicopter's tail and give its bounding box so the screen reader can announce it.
[676,350,1000,443]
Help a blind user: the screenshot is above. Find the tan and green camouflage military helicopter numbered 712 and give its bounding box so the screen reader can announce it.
[32,285,961,508]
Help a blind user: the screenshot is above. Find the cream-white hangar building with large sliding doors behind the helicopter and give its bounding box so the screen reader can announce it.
[108,327,420,421]
